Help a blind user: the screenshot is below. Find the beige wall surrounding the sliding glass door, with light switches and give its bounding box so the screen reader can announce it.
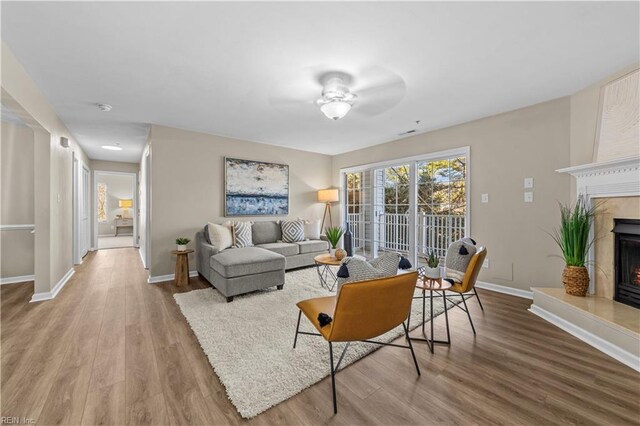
[333,97,570,290]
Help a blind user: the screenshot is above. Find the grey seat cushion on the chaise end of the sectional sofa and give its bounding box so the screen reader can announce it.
[210,247,286,278]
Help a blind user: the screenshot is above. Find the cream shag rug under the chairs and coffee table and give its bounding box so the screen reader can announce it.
[174,268,453,418]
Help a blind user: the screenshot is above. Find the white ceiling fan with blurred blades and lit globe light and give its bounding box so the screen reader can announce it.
[269,67,406,120]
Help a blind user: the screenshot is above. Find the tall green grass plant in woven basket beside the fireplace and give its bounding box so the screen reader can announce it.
[551,197,595,297]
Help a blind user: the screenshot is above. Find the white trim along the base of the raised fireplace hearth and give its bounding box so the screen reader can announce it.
[529,305,640,372]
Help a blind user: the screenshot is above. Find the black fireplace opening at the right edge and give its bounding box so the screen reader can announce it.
[613,219,640,309]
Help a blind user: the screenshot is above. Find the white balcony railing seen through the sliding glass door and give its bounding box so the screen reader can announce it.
[347,213,466,257]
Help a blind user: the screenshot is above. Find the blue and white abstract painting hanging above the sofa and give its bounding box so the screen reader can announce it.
[224,158,289,216]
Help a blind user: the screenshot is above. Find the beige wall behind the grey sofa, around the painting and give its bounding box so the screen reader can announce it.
[150,126,331,277]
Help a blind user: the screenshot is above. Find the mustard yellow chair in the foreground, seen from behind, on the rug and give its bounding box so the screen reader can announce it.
[293,272,420,413]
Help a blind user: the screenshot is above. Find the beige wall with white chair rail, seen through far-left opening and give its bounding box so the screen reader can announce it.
[0,121,34,278]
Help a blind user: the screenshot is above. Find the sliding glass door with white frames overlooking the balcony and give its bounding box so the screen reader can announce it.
[342,148,469,265]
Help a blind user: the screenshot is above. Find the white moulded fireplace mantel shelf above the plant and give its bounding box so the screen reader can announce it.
[556,156,640,198]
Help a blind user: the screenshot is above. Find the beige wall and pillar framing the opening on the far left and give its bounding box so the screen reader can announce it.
[2,43,89,293]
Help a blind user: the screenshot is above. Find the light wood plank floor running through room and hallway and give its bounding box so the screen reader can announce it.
[1,248,640,425]
